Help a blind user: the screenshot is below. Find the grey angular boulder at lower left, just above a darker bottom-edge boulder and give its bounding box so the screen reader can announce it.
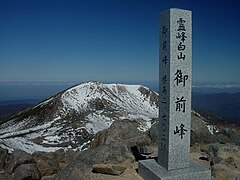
[6,149,35,174]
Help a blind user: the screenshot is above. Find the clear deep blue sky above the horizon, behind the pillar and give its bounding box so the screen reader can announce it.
[0,0,240,82]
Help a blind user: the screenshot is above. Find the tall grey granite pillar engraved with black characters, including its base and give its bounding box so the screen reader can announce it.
[139,8,211,180]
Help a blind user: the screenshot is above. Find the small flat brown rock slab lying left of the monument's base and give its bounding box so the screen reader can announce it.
[92,164,126,175]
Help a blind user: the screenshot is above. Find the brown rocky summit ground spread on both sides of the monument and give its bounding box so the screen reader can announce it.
[0,113,240,180]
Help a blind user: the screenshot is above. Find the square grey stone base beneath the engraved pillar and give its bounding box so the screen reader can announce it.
[138,159,211,180]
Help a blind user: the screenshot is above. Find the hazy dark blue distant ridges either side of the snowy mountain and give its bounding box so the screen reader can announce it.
[0,87,240,124]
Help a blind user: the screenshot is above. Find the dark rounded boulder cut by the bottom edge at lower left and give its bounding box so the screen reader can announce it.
[13,163,40,180]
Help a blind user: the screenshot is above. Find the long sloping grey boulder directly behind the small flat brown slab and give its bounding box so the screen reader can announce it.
[56,142,135,180]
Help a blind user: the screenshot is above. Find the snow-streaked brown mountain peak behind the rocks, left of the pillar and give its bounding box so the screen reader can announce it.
[0,82,158,153]
